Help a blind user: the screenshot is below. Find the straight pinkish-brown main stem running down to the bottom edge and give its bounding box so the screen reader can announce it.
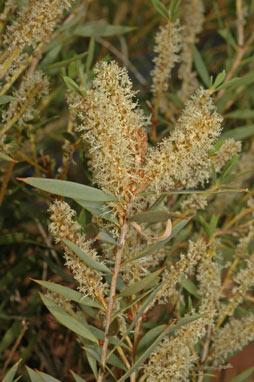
[97,218,128,382]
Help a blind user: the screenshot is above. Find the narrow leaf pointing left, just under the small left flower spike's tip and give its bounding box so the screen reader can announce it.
[33,280,102,309]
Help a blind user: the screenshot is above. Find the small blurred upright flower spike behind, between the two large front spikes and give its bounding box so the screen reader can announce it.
[151,20,182,95]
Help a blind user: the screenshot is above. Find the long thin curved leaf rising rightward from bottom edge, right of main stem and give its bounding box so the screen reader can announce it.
[117,314,202,382]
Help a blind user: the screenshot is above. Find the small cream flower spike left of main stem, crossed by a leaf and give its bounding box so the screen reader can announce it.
[49,201,107,298]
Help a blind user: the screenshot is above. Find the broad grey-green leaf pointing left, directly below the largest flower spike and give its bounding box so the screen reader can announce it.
[18,178,117,202]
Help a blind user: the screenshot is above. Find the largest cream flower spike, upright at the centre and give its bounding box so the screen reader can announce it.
[72,62,149,201]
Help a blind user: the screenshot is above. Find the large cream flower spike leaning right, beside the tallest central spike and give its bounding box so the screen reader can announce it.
[145,89,222,192]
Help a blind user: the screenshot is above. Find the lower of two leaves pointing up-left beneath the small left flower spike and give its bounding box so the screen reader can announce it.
[40,293,98,343]
